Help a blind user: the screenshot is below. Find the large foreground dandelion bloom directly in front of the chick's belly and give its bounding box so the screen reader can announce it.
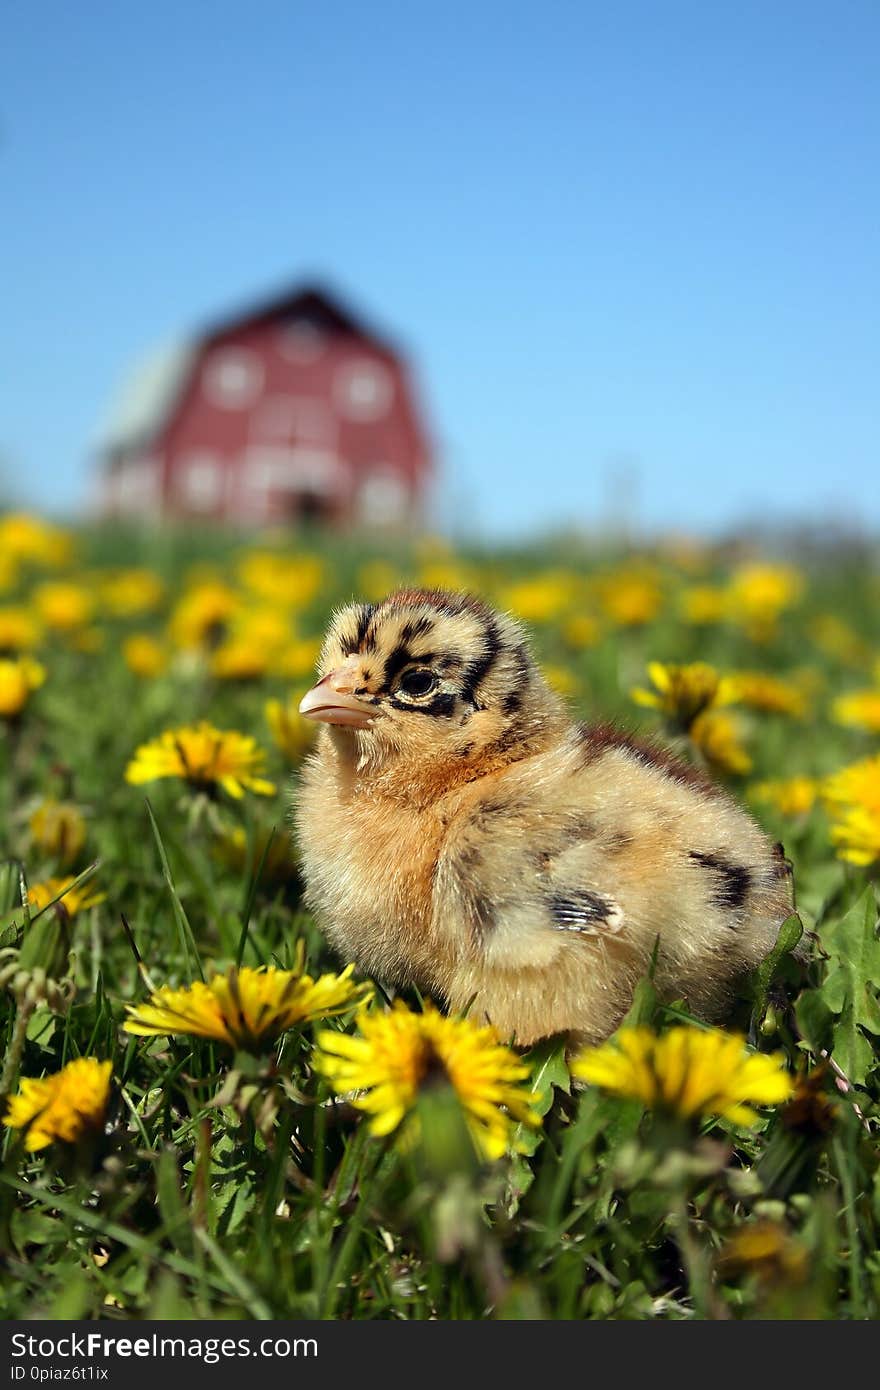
[314,1001,541,1159]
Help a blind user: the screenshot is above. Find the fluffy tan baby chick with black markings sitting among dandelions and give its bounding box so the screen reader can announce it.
[295,589,791,1044]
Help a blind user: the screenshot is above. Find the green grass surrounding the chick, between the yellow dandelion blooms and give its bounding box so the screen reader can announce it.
[0,519,880,1319]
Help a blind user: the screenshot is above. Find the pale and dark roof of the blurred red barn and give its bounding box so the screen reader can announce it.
[96,285,398,453]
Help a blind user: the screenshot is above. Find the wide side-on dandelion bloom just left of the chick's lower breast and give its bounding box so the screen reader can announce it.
[125,942,373,1052]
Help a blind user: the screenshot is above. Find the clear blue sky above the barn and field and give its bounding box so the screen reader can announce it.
[0,0,880,535]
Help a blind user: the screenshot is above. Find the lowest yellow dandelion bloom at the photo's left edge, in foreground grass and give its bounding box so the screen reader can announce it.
[3,1056,113,1154]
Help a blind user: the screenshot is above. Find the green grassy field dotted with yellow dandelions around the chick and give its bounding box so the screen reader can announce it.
[0,516,880,1319]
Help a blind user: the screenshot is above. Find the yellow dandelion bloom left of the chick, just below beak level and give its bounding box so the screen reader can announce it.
[125,720,275,798]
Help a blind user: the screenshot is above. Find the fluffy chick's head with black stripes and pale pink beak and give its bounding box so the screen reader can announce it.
[300,589,566,767]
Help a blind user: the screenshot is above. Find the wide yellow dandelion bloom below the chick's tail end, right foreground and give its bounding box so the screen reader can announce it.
[571,1026,792,1125]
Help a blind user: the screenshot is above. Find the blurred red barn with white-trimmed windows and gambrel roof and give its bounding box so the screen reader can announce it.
[99,289,431,525]
